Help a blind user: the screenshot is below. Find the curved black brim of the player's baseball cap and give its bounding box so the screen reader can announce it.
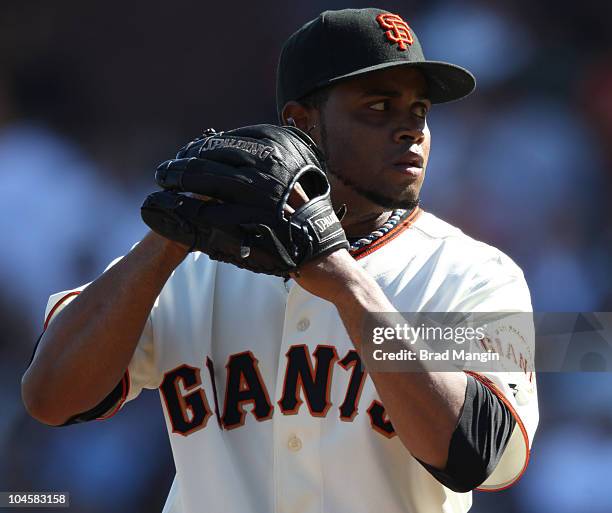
[328,60,476,103]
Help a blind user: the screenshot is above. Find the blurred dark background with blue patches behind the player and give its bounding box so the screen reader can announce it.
[0,0,612,513]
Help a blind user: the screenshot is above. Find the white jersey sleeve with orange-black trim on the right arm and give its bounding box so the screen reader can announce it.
[453,252,539,491]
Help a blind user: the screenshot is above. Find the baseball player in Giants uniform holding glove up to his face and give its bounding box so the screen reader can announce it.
[22,8,538,513]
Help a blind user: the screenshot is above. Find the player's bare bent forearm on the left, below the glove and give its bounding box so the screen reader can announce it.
[22,234,186,424]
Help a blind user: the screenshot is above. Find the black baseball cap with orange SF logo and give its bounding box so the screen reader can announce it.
[276,8,476,117]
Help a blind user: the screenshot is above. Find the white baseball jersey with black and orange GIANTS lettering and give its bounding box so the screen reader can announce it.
[47,209,538,513]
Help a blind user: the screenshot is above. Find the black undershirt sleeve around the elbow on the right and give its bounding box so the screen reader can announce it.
[418,375,516,493]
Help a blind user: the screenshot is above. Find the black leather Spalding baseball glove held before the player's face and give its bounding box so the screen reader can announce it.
[141,125,349,277]
